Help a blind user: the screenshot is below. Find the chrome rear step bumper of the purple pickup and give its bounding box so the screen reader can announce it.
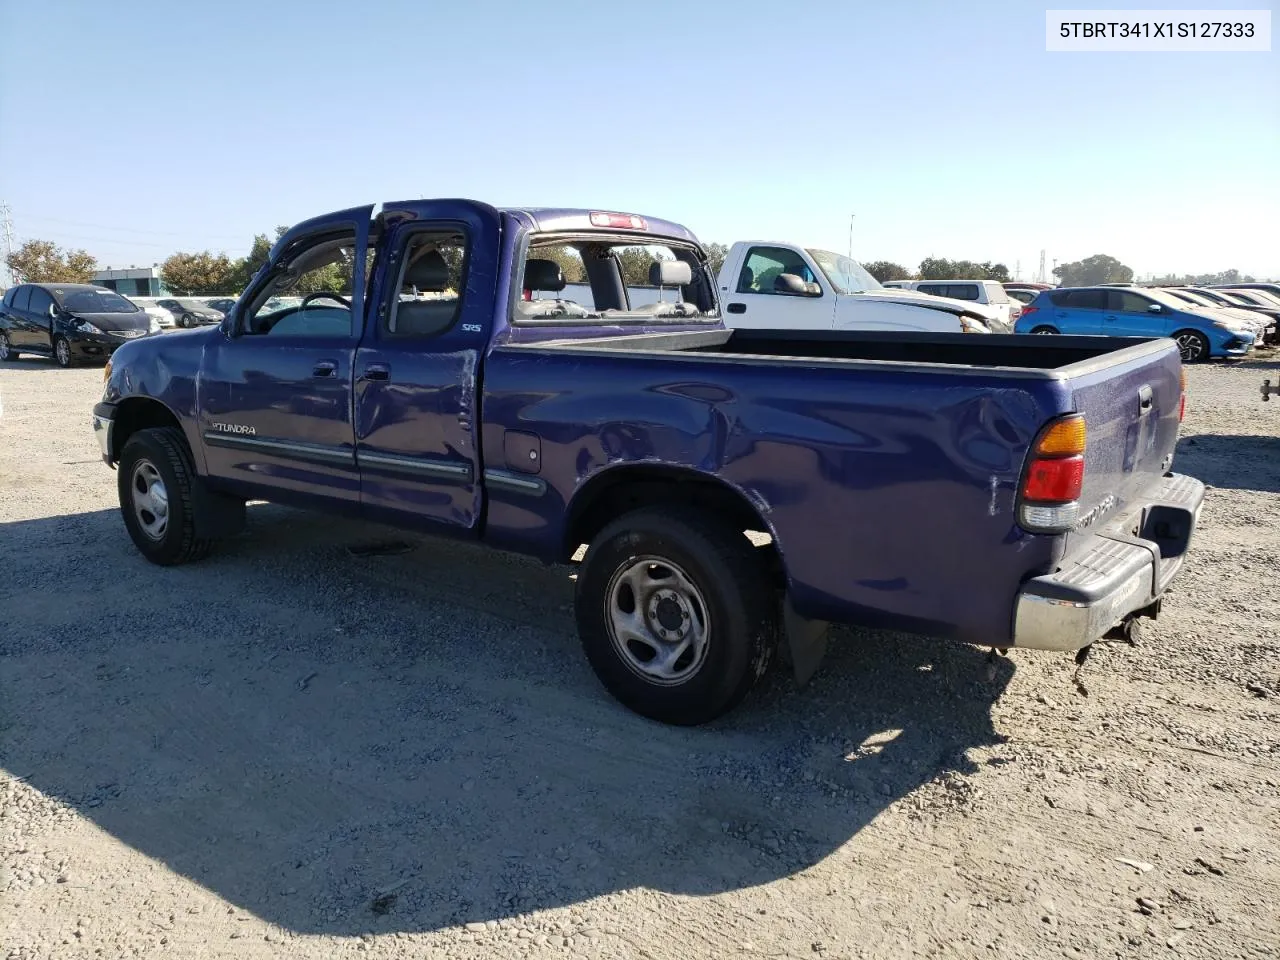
[1012,474,1204,650]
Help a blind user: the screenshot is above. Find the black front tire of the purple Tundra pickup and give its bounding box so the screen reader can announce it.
[116,426,214,567]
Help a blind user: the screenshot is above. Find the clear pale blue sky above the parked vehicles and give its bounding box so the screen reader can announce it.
[0,0,1280,278]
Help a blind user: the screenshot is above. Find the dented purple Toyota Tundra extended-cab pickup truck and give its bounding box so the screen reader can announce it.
[93,200,1203,724]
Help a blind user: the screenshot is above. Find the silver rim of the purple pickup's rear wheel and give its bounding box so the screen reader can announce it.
[604,557,710,686]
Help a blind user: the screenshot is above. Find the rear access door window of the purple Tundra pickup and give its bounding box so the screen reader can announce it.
[381,230,467,339]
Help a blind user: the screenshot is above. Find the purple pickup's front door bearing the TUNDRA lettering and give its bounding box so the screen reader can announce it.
[198,206,372,509]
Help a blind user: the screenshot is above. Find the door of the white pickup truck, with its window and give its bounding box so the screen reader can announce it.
[721,246,836,330]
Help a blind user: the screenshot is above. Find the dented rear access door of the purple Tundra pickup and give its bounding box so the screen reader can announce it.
[355,201,500,534]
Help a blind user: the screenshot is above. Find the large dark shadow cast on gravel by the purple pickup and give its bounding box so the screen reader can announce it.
[0,506,1012,934]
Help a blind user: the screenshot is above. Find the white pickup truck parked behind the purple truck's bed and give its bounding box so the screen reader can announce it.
[717,241,997,333]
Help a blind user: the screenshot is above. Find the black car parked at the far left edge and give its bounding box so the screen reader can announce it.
[0,283,160,366]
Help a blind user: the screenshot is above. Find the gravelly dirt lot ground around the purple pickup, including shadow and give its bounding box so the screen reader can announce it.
[0,358,1280,960]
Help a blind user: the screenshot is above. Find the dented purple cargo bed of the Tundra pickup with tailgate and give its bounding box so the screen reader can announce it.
[481,329,1180,645]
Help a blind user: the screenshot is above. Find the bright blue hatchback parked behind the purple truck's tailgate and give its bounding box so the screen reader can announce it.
[1014,287,1256,364]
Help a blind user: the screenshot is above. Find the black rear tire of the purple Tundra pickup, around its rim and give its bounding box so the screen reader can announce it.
[576,507,780,726]
